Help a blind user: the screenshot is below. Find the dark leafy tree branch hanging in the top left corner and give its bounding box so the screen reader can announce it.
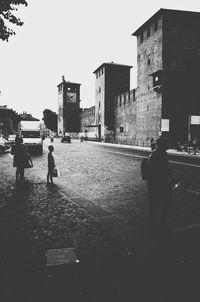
[0,0,28,41]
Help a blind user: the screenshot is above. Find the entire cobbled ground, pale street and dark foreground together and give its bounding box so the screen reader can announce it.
[0,140,200,302]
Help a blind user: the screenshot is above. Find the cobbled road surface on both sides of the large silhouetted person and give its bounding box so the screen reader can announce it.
[31,140,200,231]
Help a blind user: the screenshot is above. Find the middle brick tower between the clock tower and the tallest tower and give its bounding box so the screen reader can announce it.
[93,62,132,141]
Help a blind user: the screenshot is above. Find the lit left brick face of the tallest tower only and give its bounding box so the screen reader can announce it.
[135,16,163,146]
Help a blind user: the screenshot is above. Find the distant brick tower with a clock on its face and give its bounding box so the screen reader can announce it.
[57,76,81,135]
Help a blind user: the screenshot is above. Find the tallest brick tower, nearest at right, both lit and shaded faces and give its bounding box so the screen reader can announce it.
[133,9,200,145]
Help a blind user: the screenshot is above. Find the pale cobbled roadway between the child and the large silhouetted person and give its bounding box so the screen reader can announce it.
[32,140,148,225]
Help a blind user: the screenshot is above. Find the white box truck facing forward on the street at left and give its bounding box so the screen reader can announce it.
[20,121,43,154]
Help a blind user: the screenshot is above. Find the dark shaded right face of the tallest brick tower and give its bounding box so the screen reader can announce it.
[162,11,200,145]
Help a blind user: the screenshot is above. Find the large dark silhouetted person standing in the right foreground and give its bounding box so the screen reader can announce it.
[148,137,172,228]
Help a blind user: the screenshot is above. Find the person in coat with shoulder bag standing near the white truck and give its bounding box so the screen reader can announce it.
[11,136,33,182]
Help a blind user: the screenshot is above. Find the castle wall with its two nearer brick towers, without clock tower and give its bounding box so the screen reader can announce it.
[57,9,200,146]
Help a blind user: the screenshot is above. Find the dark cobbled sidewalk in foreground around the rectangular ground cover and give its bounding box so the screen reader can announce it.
[0,155,199,302]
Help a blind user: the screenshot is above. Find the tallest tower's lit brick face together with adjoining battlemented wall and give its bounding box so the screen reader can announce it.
[115,17,163,146]
